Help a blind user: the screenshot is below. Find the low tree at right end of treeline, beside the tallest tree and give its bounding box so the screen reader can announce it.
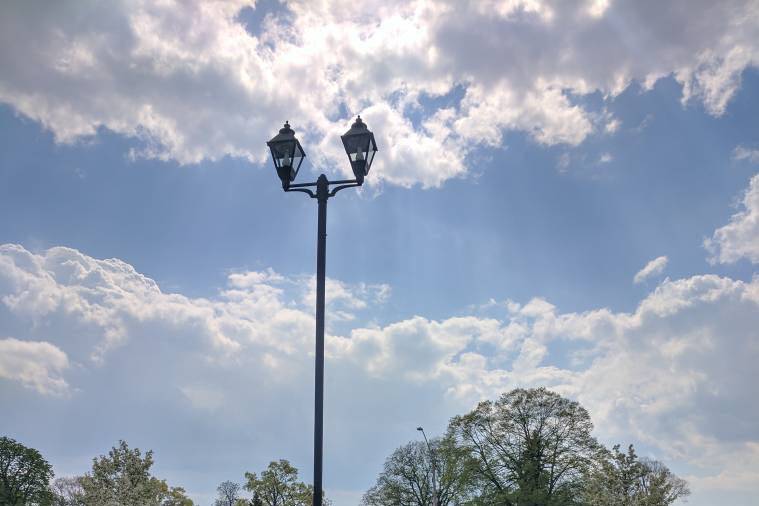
[583,445,690,506]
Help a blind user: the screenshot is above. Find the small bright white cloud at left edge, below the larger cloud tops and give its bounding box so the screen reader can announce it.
[0,337,69,396]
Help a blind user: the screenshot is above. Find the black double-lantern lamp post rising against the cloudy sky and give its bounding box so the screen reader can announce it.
[266,116,377,506]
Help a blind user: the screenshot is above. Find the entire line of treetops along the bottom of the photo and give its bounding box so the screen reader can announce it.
[0,388,689,506]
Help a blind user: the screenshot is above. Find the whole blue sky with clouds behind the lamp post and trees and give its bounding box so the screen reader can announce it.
[0,0,759,506]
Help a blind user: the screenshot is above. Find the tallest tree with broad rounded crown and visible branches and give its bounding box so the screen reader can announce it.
[449,388,601,506]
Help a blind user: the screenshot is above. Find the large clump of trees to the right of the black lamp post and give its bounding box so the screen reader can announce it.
[362,388,689,506]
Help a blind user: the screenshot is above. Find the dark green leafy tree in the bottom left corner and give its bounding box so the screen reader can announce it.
[0,437,53,506]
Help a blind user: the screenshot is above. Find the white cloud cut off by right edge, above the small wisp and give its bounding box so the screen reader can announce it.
[704,174,759,264]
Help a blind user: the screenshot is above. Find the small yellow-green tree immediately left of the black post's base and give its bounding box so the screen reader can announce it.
[245,460,320,506]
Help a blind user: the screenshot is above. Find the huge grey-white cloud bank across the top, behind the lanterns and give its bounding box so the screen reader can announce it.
[0,0,759,187]
